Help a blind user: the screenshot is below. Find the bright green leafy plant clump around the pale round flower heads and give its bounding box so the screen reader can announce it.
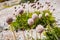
[11,10,60,40]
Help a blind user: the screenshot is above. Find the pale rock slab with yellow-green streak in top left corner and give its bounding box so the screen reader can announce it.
[0,0,21,10]
